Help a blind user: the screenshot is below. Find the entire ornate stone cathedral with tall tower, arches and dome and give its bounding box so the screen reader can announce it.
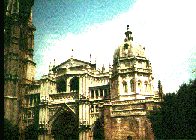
[4,0,161,140]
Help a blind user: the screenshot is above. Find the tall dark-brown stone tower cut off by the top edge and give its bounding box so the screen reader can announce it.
[4,0,36,126]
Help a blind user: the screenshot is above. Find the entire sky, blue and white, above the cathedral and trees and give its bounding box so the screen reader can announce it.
[33,0,196,93]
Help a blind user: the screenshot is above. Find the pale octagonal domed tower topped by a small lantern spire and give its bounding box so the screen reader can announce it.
[111,25,153,99]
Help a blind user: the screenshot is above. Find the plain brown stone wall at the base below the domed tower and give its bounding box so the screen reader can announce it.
[103,105,154,140]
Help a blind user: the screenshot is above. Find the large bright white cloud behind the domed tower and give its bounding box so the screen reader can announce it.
[35,0,196,92]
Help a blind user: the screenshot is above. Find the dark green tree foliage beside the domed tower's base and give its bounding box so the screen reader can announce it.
[147,79,196,139]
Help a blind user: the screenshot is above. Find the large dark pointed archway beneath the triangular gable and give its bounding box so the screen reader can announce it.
[51,110,79,140]
